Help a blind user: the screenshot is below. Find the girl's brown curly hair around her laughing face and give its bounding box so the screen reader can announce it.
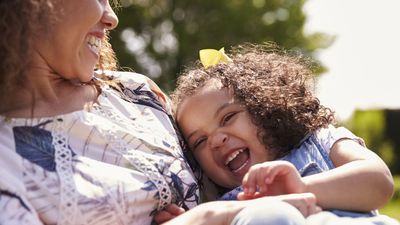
[171,44,335,157]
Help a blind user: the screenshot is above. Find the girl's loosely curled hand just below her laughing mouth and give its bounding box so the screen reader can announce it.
[238,160,306,200]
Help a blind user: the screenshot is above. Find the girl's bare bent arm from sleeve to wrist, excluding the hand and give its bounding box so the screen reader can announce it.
[303,139,393,211]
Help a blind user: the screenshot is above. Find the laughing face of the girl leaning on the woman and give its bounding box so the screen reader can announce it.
[177,81,272,188]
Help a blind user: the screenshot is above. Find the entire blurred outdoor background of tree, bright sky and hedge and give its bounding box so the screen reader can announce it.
[111,0,400,220]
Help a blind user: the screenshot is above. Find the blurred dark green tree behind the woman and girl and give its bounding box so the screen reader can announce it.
[111,0,333,91]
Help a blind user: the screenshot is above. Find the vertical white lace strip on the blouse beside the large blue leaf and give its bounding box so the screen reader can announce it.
[52,119,78,225]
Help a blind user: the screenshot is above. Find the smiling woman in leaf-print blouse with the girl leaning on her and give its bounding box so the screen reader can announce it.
[0,0,315,225]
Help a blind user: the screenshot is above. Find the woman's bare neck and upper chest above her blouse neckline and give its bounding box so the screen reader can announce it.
[0,69,98,118]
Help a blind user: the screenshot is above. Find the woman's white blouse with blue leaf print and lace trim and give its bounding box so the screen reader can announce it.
[0,72,199,225]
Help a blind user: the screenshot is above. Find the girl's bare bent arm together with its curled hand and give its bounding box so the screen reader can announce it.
[238,139,393,211]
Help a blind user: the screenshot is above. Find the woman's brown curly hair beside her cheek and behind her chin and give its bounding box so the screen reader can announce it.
[0,0,118,105]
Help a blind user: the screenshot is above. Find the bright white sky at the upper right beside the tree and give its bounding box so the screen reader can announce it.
[304,0,400,121]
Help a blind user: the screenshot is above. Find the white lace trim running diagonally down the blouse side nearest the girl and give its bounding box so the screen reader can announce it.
[92,105,172,210]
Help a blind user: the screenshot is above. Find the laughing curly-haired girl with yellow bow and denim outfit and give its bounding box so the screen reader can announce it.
[155,45,393,223]
